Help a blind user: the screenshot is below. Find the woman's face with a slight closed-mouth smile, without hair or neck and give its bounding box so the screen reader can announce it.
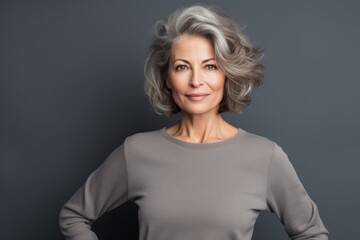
[166,34,225,115]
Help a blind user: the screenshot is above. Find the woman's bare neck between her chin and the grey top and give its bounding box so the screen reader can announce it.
[168,112,238,143]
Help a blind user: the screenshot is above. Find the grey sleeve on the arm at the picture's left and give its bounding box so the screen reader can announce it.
[59,144,128,240]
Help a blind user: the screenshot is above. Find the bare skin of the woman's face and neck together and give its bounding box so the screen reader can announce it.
[166,34,238,143]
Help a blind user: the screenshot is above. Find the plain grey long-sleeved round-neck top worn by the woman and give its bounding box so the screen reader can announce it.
[59,128,328,240]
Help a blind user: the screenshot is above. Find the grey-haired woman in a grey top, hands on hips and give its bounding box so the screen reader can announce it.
[60,6,328,240]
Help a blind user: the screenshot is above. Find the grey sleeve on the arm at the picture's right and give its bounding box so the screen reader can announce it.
[267,144,329,240]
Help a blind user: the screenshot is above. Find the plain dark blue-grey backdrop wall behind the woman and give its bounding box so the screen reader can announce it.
[0,0,360,240]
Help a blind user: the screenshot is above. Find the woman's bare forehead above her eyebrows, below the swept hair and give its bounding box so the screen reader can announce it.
[171,34,215,58]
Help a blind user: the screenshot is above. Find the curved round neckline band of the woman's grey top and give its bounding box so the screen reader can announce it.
[160,127,246,149]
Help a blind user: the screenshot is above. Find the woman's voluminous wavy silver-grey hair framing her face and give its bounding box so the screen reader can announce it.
[144,5,264,116]
